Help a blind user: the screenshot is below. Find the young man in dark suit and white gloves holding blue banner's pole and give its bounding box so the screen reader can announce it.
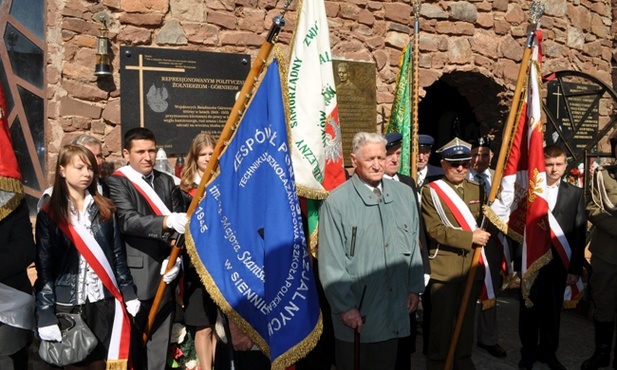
[107,127,187,370]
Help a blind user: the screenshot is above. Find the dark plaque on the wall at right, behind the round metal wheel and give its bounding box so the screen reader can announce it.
[544,81,599,151]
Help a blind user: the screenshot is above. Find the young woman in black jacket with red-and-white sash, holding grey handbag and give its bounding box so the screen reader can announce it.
[35,144,140,370]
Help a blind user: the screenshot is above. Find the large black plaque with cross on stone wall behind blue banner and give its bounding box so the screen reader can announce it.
[120,47,251,155]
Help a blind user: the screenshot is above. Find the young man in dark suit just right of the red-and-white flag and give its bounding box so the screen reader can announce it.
[519,145,586,370]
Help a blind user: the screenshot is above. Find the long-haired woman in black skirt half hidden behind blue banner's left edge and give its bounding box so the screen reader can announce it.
[180,132,216,370]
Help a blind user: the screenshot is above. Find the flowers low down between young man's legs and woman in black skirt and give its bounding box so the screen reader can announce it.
[167,323,200,370]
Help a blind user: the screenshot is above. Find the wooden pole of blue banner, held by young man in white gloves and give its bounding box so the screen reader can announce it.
[143,14,289,345]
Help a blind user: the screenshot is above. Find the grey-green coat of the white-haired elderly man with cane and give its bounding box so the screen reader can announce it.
[319,175,424,343]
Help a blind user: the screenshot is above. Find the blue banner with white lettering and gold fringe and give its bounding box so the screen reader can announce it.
[187,60,322,370]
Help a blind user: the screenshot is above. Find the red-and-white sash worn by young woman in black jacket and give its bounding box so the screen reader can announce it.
[58,215,131,369]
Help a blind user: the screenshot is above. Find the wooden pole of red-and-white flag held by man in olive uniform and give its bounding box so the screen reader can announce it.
[444,1,544,370]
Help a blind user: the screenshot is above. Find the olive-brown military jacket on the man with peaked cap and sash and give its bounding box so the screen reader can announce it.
[422,177,483,281]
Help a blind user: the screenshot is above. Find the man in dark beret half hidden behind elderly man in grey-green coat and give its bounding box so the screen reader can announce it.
[383,132,431,370]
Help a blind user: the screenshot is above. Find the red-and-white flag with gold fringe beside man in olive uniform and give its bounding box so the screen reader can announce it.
[491,30,552,306]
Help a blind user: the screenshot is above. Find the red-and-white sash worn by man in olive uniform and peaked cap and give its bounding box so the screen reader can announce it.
[429,180,495,309]
